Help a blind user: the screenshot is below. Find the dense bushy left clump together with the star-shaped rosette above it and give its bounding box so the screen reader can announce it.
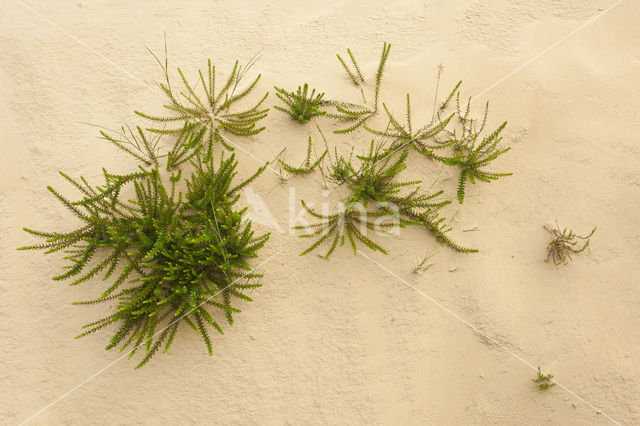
[21,45,269,367]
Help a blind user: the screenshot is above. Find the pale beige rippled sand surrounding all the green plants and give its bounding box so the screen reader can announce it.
[0,0,640,424]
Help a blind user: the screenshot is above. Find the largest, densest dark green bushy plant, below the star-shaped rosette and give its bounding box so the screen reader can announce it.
[20,154,269,367]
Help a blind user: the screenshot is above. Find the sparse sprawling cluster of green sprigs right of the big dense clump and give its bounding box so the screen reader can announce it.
[276,43,511,257]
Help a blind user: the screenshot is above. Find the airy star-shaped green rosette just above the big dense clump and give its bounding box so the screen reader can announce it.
[136,46,269,156]
